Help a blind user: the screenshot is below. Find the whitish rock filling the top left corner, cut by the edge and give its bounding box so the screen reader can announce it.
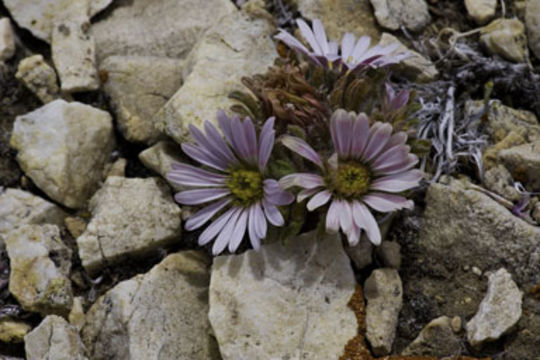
[4,0,112,42]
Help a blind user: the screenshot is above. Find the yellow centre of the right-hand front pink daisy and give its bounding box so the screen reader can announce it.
[334,163,371,198]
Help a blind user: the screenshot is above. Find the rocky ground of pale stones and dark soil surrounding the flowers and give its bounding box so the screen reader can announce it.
[0,0,540,360]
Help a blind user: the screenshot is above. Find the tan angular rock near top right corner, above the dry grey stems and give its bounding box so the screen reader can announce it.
[480,19,527,62]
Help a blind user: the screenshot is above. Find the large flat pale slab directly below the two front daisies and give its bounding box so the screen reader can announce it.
[209,233,358,360]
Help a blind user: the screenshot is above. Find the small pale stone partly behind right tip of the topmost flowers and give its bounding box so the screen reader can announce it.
[380,33,439,82]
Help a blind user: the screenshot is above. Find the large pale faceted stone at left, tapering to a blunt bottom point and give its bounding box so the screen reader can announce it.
[10,100,114,208]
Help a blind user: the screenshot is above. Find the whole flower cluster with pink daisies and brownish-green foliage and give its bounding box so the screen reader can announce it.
[167,20,422,255]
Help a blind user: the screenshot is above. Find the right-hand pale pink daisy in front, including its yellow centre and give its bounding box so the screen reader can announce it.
[279,110,422,246]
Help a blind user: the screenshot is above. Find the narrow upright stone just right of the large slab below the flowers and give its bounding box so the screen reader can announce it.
[364,268,403,356]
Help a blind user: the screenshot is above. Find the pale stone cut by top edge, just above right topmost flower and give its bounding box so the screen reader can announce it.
[371,0,431,31]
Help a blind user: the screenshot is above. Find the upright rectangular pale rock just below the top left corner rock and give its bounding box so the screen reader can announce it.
[51,20,99,93]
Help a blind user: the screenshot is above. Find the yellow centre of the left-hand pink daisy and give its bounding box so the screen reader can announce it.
[227,169,264,206]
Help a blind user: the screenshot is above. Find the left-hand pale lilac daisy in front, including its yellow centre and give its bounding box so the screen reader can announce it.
[167,111,294,255]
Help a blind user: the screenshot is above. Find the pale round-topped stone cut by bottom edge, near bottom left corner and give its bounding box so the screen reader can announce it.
[24,315,88,360]
